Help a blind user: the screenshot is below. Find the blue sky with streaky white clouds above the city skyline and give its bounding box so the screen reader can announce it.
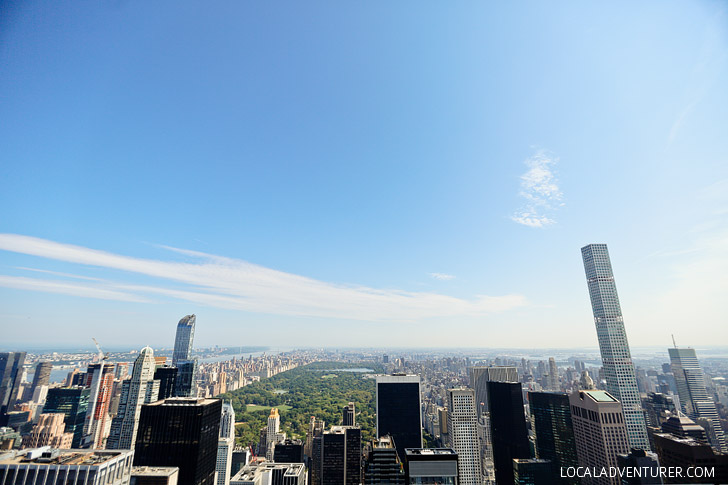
[0,1,728,347]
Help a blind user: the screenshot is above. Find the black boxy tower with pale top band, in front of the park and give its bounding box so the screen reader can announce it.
[376,374,422,459]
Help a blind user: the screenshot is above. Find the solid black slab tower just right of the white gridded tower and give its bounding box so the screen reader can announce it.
[488,381,531,485]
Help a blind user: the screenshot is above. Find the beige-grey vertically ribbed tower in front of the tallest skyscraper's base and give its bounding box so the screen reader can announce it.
[569,391,630,485]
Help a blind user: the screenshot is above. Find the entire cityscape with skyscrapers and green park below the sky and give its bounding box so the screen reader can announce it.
[0,244,728,485]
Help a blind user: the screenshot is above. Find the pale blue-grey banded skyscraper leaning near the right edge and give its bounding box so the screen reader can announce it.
[667,347,728,453]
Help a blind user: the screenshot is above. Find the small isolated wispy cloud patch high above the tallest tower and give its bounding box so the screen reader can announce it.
[511,150,564,227]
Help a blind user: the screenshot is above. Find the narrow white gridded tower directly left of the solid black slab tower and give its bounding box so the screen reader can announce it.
[447,388,483,485]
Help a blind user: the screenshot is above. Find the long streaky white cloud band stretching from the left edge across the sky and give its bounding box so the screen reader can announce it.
[0,234,528,321]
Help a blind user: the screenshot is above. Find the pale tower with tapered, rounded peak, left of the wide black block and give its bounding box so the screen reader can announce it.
[106,347,159,450]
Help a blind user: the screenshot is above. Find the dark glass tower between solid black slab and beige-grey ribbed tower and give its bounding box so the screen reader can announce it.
[528,392,579,484]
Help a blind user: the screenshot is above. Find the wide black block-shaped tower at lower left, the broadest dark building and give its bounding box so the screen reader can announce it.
[134,398,222,485]
